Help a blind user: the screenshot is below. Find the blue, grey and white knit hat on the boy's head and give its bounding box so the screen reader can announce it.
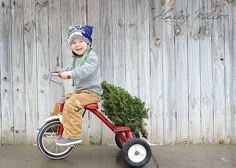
[68,25,93,45]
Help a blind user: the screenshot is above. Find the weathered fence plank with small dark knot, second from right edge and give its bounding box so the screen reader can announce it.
[211,0,226,143]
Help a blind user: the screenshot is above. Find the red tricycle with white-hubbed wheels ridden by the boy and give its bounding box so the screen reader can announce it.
[37,72,152,167]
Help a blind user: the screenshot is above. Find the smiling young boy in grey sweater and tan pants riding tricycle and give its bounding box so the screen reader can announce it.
[57,25,103,146]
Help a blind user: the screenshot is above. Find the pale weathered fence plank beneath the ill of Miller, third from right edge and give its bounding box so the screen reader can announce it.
[200,0,213,143]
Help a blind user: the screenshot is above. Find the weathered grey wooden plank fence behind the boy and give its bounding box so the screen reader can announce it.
[0,0,236,144]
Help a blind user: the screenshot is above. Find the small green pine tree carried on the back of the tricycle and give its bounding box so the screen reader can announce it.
[102,81,148,137]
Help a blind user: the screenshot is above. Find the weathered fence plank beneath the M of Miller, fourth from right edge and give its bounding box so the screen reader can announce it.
[187,1,202,144]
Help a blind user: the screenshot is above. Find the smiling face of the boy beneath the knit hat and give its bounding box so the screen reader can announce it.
[70,38,88,55]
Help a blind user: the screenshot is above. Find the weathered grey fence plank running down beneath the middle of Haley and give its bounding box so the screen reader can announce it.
[160,0,177,144]
